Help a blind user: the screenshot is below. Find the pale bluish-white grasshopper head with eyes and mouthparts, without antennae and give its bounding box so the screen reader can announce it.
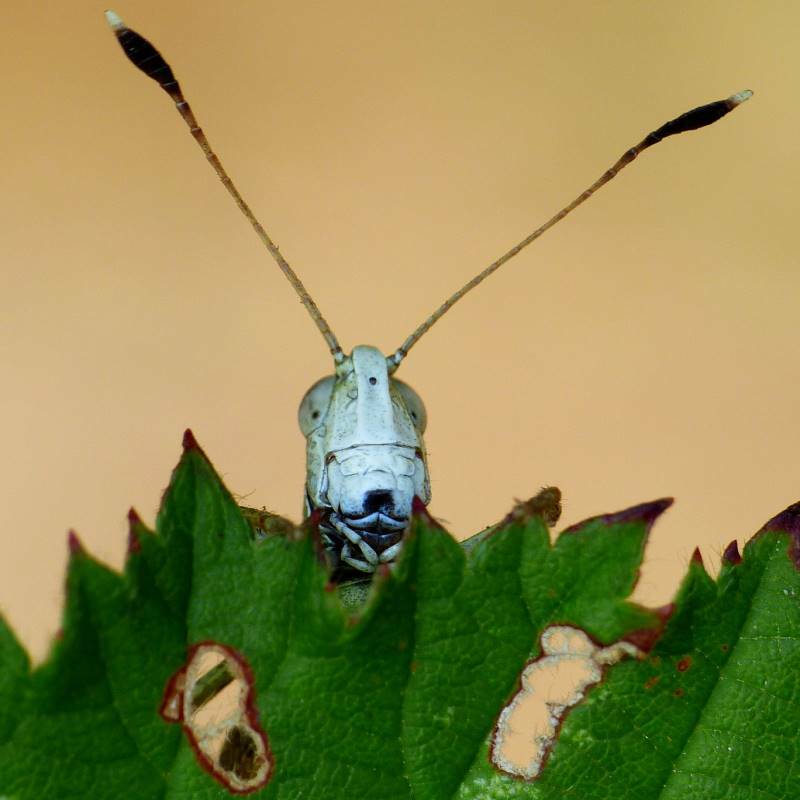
[298,345,430,572]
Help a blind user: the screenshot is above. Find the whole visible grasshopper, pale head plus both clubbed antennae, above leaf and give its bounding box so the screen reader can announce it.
[106,11,753,575]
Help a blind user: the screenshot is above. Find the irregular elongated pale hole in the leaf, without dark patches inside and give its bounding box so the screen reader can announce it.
[489,625,643,781]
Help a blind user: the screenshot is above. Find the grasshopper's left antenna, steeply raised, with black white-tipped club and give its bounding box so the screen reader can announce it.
[106,10,344,364]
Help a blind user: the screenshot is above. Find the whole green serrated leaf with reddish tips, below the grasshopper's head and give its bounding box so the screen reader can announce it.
[0,432,800,800]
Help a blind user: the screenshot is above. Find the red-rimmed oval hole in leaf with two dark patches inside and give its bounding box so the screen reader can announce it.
[160,642,274,794]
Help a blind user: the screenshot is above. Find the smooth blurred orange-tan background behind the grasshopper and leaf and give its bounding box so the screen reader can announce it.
[0,0,800,658]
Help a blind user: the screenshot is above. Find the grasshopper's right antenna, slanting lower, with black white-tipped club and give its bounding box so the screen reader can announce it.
[387,89,753,372]
